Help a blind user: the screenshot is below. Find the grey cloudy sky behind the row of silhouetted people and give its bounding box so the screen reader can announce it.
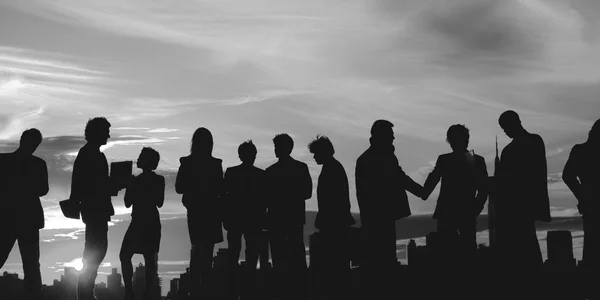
[0,0,600,290]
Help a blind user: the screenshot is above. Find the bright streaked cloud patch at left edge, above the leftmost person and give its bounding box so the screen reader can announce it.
[0,47,115,139]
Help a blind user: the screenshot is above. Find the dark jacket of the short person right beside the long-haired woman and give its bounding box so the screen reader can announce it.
[223,164,267,231]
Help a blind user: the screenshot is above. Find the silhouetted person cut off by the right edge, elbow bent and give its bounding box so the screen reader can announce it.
[562,119,600,299]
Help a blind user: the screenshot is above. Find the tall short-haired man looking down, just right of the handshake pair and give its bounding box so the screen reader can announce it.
[496,110,551,270]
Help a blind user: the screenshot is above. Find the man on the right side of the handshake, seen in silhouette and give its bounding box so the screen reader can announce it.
[423,124,488,264]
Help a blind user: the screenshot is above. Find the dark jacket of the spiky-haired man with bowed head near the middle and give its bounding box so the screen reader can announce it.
[315,158,356,230]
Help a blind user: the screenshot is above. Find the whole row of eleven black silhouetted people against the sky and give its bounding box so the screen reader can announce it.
[0,111,600,300]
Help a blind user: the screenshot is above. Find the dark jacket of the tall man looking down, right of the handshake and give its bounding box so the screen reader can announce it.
[496,133,551,222]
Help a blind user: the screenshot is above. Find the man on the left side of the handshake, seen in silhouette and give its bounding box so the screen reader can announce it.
[355,120,423,295]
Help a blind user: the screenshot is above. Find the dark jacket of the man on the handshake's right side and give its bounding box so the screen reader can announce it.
[424,152,488,219]
